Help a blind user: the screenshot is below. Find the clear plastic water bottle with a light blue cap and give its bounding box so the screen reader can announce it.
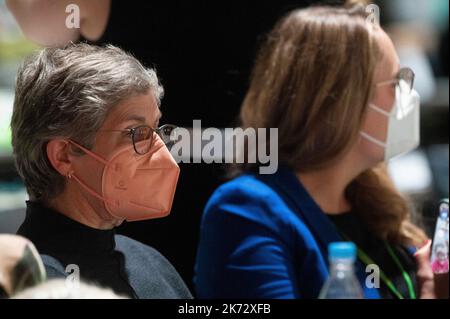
[319,242,364,299]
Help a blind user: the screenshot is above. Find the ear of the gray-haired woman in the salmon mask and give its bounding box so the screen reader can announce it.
[47,139,72,176]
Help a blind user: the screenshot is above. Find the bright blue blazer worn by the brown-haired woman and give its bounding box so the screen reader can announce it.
[194,167,380,299]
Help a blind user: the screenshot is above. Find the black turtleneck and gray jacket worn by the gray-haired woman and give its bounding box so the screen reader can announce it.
[18,202,192,299]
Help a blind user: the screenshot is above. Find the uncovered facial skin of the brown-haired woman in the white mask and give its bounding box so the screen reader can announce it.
[359,29,400,166]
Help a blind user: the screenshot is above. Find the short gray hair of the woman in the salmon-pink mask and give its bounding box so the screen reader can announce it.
[11,43,163,202]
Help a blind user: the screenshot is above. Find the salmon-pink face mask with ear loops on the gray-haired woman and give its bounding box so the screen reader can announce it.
[68,133,180,221]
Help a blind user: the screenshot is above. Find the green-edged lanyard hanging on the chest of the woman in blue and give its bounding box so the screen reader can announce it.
[343,234,416,299]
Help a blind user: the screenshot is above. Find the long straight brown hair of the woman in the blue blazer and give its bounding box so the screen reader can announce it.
[240,5,426,245]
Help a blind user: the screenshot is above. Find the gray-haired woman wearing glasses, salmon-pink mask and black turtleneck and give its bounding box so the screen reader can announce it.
[11,44,191,298]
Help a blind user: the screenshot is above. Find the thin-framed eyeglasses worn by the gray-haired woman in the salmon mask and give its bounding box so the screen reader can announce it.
[99,124,178,155]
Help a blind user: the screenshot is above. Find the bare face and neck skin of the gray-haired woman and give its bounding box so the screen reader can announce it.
[51,93,161,229]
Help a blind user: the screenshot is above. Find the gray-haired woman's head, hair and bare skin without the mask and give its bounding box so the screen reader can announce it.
[11,44,167,226]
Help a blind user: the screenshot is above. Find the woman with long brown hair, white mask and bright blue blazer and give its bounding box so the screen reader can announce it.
[195,6,442,298]
